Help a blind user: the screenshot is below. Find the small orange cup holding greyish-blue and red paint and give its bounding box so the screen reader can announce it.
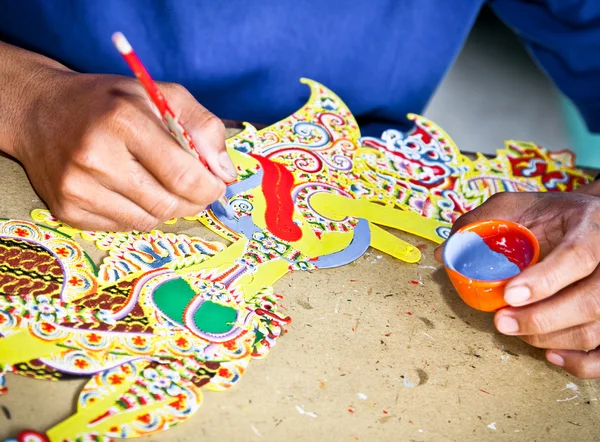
[443,220,540,312]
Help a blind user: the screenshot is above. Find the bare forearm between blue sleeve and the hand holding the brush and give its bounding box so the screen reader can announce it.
[0,41,69,158]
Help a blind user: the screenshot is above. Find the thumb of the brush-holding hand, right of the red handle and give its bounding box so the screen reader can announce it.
[165,84,237,183]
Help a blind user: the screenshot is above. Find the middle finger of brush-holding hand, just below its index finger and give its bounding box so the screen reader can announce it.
[102,153,205,221]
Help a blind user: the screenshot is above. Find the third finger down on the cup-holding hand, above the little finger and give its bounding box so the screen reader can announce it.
[521,321,600,351]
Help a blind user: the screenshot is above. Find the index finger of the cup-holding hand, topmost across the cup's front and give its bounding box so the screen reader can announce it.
[504,230,600,306]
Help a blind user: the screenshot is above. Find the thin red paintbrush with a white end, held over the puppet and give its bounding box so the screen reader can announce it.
[112,32,234,218]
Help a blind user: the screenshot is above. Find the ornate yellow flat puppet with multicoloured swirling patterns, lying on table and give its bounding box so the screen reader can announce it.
[0,80,588,442]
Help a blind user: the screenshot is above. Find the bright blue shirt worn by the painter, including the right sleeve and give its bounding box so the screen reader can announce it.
[0,0,600,135]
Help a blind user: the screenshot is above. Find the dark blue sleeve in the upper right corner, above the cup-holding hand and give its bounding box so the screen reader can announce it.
[489,0,600,133]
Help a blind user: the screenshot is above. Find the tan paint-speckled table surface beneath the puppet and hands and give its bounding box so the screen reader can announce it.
[0,132,600,442]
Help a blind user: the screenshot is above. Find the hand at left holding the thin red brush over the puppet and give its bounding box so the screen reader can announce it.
[13,70,235,231]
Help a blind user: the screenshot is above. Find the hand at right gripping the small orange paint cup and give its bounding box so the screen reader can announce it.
[436,193,600,378]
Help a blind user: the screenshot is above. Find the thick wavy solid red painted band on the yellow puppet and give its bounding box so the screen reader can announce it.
[250,153,302,242]
